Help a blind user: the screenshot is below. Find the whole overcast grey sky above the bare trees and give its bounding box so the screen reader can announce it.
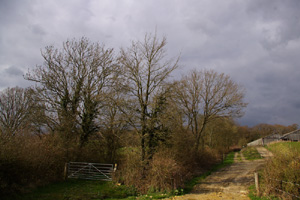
[0,0,300,126]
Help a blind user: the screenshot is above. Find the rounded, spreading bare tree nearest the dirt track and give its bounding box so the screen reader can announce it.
[176,70,247,150]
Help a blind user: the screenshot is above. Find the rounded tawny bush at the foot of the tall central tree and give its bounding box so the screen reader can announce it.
[116,147,184,194]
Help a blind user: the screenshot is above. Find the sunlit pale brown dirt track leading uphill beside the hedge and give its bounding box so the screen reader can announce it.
[166,147,271,200]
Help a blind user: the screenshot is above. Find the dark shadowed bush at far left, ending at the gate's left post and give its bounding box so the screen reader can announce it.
[0,136,65,194]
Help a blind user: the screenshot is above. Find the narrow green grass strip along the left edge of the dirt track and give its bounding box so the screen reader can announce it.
[184,152,235,193]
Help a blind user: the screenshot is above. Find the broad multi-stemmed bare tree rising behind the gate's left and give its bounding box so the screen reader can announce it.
[25,38,115,145]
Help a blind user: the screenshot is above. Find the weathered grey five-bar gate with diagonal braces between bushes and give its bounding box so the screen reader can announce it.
[65,162,116,181]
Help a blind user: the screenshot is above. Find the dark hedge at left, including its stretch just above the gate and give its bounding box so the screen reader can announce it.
[0,134,108,195]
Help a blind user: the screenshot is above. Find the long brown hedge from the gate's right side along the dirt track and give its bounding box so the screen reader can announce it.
[116,143,220,194]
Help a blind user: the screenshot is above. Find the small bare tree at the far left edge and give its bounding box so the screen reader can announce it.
[0,87,35,136]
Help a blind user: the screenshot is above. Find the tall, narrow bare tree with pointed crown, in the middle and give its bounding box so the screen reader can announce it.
[120,34,179,160]
